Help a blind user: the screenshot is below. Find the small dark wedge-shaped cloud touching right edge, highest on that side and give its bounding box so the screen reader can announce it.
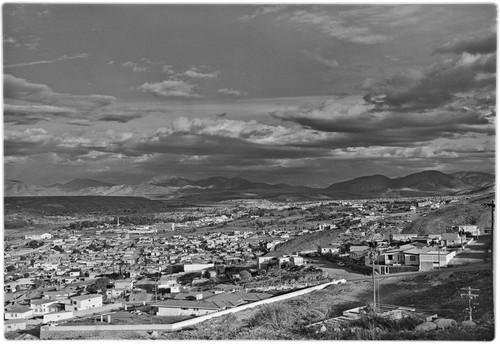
[434,33,497,55]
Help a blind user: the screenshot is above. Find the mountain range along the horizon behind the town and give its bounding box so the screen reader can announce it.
[4,171,495,201]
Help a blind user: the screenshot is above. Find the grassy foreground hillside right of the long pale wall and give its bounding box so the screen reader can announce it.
[161,270,494,341]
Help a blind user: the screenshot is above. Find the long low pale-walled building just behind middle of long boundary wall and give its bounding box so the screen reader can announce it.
[153,300,221,316]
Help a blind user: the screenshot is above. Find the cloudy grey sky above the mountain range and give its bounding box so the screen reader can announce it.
[2,3,497,187]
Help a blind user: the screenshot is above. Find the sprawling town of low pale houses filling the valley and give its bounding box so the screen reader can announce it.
[4,196,491,338]
